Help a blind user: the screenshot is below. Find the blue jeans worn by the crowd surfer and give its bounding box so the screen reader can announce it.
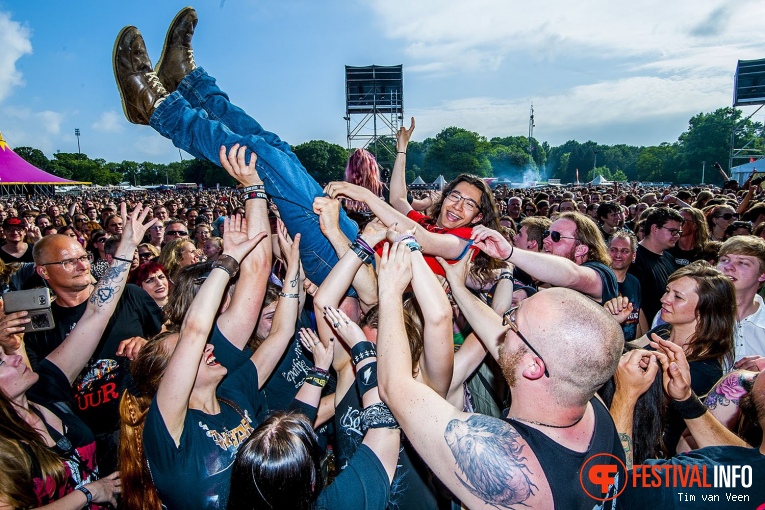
[151,67,358,285]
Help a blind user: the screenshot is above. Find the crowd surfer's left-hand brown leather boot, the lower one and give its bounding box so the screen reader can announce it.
[112,27,167,124]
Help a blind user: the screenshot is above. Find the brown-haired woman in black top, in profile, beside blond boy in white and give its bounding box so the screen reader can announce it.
[632,261,736,451]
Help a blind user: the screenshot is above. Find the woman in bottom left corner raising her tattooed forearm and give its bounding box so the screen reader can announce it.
[0,207,155,508]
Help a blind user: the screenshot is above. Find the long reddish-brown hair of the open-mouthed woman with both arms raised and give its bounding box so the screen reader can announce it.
[119,332,176,510]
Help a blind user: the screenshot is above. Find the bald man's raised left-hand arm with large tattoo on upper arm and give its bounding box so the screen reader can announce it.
[377,243,552,509]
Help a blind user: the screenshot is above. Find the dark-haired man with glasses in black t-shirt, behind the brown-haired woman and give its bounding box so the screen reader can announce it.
[628,207,683,324]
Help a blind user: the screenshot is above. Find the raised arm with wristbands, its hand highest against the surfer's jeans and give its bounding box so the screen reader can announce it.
[217,145,272,349]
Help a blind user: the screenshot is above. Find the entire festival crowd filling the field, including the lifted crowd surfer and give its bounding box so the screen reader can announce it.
[0,8,765,510]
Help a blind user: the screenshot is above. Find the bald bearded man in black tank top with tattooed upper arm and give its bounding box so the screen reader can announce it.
[377,243,625,509]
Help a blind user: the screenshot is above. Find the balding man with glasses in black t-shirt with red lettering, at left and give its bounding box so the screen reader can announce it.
[24,224,162,472]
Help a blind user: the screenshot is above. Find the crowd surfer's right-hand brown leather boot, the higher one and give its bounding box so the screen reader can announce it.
[154,7,198,92]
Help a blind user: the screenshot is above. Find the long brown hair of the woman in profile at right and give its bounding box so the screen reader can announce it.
[667,260,736,365]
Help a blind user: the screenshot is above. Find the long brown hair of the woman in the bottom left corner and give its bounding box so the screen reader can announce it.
[0,391,66,508]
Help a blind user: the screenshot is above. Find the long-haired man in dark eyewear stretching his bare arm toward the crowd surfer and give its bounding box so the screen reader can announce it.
[473,213,618,304]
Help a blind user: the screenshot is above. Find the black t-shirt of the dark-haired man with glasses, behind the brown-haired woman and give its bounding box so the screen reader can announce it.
[628,245,677,324]
